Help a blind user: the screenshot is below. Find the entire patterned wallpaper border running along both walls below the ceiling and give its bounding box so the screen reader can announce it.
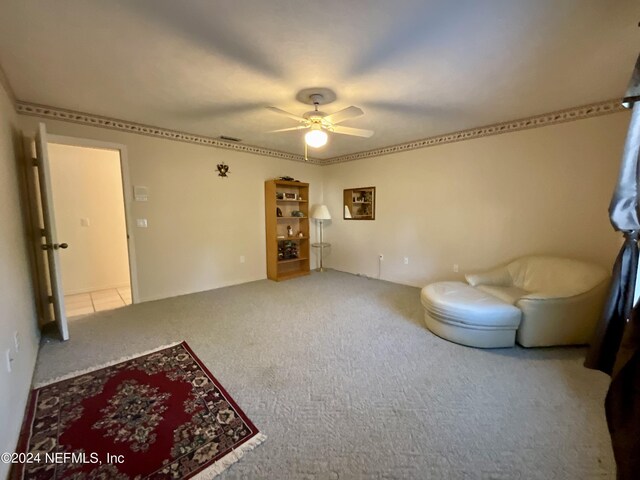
[15,99,625,165]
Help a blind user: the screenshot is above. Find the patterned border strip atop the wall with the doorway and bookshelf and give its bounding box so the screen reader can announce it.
[15,100,321,164]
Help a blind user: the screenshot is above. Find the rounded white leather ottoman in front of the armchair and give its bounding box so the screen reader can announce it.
[420,282,522,348]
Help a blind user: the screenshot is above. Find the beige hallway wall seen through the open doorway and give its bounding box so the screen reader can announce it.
[49,143,129,295]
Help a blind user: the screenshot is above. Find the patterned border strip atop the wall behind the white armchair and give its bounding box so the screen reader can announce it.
[322,99,626,165]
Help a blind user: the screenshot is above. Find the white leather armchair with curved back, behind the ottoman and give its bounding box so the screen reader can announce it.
[465,256,609,347]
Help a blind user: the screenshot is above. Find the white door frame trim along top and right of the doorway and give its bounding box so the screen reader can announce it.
[47,134,140,304]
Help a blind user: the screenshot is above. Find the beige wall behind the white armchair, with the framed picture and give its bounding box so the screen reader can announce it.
[323,113,629,286]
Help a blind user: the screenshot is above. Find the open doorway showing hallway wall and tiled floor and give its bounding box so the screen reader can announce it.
[47,139,135,320]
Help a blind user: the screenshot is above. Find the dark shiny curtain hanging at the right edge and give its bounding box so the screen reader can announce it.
[585,52,640,480]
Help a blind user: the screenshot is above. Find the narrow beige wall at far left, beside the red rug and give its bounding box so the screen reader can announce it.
[0,86,39,478]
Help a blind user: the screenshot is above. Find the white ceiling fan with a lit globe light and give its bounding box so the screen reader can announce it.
[267,88,373,157]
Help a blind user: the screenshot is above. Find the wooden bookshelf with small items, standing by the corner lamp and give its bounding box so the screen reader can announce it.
[264,180,310,281]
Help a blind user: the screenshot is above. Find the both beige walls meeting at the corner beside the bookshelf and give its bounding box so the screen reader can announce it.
[19,113,628,300]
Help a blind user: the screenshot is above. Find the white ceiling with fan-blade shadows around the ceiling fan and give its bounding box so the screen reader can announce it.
[0,0,640,158]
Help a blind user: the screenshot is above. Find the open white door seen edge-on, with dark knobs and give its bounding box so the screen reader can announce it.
[36,123,69,340]
